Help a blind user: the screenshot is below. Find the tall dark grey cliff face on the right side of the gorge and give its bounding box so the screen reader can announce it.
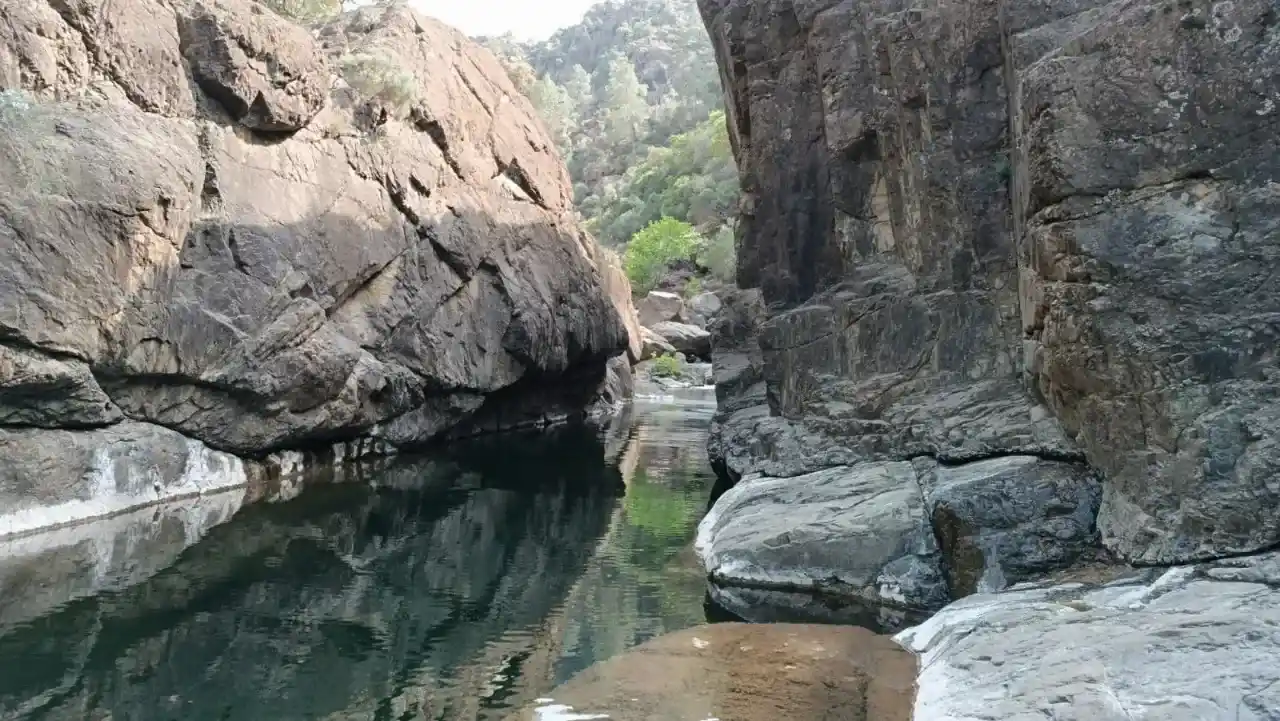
[699,0,1280,609]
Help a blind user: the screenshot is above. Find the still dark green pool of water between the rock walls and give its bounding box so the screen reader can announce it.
[0,400,714,721]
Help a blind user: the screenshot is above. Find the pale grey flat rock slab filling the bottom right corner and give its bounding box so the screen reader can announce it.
[896,556,1280,721]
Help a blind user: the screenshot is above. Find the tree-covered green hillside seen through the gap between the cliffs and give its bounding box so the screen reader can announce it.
[484,0,737,286]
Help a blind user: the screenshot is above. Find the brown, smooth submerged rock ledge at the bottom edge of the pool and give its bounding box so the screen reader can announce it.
[508,624,915,721]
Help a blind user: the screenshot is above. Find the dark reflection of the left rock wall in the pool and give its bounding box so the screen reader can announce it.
[0,429,621,721]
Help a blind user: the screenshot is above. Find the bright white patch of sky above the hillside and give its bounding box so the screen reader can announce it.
[411,0,609,40]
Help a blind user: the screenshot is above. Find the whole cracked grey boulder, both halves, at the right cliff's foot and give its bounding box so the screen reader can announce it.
[696,456,1101,610]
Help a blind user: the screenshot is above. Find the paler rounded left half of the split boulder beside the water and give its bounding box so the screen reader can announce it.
[695,462,947,608]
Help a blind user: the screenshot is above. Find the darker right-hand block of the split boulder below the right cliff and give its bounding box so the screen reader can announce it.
[914,456,1102,598]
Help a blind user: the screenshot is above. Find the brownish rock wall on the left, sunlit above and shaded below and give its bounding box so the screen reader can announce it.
[0,0,639,530]
